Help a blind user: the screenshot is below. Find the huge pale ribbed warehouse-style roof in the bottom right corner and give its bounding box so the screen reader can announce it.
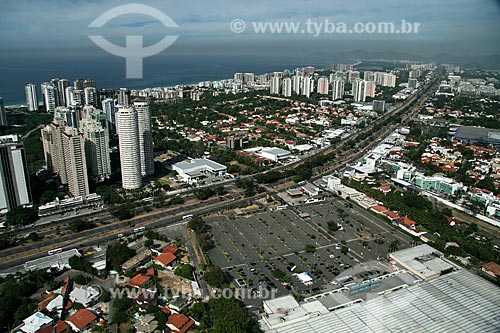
[266,269,500,333]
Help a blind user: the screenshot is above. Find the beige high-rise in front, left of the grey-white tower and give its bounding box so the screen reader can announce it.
[62,127,89,197]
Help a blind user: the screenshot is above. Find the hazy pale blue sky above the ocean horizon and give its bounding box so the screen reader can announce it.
[0,0,500,55]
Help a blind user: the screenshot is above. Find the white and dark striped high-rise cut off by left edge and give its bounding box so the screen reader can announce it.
[0,134,32,214]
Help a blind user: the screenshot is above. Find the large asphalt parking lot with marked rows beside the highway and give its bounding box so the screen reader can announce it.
[206,199,411,296]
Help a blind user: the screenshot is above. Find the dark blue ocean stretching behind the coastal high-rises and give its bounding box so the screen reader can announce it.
[0,53,325,106]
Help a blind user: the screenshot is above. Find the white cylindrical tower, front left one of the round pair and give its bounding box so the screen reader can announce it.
[116,107,142,190]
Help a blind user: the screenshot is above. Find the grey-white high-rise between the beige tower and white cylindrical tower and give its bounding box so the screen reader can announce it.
[80,117,111,179]
